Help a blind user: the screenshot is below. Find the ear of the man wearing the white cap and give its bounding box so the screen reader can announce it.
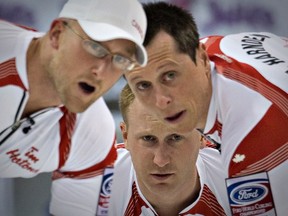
[49,19,65,49]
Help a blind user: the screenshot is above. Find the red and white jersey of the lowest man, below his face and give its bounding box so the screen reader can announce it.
[109,145,229,216]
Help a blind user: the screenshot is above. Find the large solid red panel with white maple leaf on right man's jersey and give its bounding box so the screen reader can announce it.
[229,105,288,177]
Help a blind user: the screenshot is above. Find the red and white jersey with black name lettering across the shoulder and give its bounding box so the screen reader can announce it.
[202,32,288,215]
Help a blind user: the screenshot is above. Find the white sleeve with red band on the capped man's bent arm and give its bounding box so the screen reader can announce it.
[50,99,116,216]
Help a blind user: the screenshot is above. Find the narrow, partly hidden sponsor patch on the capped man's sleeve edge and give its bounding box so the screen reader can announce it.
[96,167,114,216]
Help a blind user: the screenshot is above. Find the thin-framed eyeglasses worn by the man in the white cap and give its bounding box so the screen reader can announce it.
[63,21,136,72]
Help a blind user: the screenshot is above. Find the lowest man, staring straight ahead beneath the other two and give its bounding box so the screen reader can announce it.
[109,85,229,216]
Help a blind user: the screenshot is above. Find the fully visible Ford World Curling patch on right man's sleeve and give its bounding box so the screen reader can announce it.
[226,172,276,216]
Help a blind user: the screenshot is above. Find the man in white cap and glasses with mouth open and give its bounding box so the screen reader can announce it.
[0,0,147,216]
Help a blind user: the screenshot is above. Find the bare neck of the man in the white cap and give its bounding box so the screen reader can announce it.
[22,36,60,117]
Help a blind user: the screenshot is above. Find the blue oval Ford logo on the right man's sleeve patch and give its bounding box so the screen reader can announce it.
[230,184,268,205]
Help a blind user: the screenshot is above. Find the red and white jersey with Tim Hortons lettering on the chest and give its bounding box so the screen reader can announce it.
[0,21,116,216]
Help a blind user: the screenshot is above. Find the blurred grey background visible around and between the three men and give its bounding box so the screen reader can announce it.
[0,0,288,216]
